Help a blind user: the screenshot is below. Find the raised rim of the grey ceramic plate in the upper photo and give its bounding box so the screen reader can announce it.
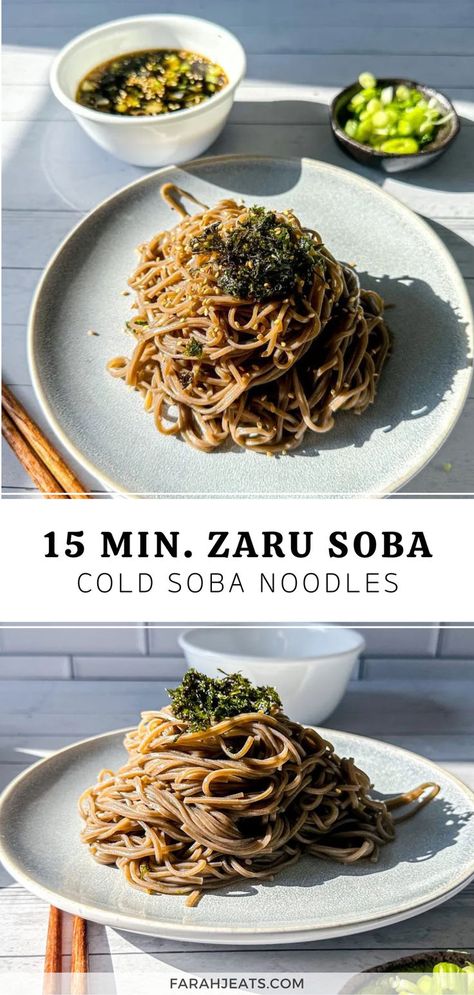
[27,154,474,497]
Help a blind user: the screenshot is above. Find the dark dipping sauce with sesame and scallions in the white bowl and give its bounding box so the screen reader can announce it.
[76,48,228,117]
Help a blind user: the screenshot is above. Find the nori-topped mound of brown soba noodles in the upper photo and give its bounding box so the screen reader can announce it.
[108,184,390,454]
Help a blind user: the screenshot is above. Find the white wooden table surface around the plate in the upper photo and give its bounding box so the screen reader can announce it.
[3,0,474,493]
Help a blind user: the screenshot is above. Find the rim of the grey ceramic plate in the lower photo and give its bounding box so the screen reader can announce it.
[0,727,474,945]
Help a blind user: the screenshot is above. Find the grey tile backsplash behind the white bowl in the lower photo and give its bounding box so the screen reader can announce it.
[0,623,474,681]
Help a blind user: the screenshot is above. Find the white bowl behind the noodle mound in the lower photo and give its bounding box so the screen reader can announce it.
[179,626,365,724]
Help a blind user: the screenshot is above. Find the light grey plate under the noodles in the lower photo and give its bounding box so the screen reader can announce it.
[0,730,474,945]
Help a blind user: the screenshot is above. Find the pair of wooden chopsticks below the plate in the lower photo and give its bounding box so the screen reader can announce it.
[43,905,89,995]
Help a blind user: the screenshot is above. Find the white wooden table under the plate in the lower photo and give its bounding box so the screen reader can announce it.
[0,679,474,995]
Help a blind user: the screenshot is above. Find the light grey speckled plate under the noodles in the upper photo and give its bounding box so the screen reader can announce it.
[29,156,472,495]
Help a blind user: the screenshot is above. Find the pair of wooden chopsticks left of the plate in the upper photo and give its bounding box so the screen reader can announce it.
[2,385,89,498]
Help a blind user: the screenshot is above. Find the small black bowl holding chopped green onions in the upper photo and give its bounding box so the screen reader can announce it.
[330,79,460,173]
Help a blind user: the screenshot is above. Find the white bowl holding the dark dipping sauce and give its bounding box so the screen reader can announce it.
[50,14,245,166]
